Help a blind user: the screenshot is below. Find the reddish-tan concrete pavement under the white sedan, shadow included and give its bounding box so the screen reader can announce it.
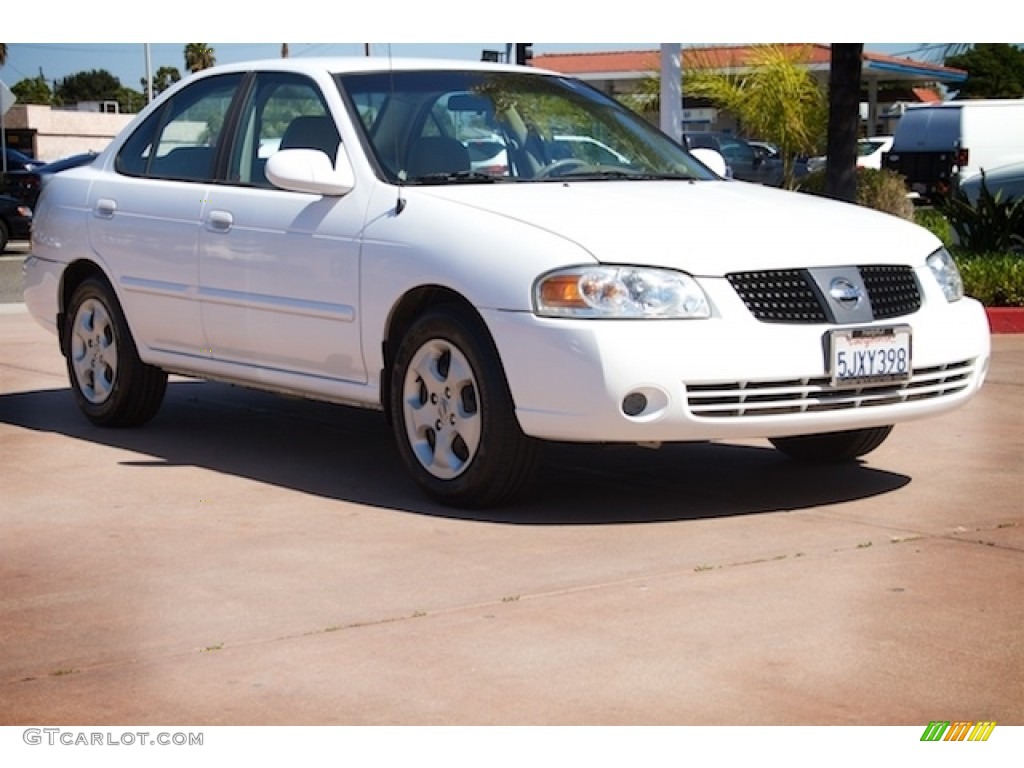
[0,304,1024,727]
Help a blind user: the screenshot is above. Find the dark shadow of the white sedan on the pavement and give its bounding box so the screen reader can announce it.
[0,381,910,525]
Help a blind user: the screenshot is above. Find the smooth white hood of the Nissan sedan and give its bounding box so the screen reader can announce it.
[417,181,941,276]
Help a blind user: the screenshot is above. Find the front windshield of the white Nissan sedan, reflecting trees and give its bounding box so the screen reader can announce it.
[338,71,716,184]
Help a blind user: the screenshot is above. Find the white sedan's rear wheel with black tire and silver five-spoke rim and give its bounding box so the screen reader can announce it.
[63,278,167,427]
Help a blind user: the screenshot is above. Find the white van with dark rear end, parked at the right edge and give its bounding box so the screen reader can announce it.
[883,99,1024,198]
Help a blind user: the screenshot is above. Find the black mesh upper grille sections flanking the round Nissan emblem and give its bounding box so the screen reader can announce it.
[725,265,921,324]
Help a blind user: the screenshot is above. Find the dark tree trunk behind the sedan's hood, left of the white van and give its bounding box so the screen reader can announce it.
[825,43,864,203]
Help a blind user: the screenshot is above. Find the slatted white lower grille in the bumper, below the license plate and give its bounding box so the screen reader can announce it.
[686,359,975,419]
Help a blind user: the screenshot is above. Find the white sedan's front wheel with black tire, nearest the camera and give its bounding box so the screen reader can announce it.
[389,305,538,508]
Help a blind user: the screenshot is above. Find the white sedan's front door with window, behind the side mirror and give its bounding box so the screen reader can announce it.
[200,73,366,389]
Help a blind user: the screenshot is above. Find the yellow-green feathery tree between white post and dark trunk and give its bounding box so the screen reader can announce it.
[683,45,827,187]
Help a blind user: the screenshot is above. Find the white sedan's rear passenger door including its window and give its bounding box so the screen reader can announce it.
[89,74,243,356]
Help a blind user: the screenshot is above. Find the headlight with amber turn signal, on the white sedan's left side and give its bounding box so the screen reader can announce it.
[534,266,711,318]
